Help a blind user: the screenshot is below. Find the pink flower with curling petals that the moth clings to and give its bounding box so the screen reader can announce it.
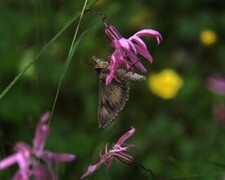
[105,24,162,85]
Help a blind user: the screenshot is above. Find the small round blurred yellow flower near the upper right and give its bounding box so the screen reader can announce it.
[200,29,217,45]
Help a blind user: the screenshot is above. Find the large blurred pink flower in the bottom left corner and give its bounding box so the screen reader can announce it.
[0,112,75,180]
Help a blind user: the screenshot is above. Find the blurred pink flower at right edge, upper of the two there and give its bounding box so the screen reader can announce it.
[208,74,225,95]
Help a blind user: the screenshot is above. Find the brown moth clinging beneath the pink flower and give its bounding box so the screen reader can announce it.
[93,57,146,128]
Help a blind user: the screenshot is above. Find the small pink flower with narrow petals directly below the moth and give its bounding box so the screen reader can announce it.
[81,127,135,179]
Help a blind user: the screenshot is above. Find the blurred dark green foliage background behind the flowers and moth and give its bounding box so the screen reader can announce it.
[0,0,225,180]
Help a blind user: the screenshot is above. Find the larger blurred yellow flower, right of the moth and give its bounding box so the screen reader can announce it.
[148,69,183,99]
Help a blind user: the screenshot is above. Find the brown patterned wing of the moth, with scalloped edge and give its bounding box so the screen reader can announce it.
[98,79,129,128]
